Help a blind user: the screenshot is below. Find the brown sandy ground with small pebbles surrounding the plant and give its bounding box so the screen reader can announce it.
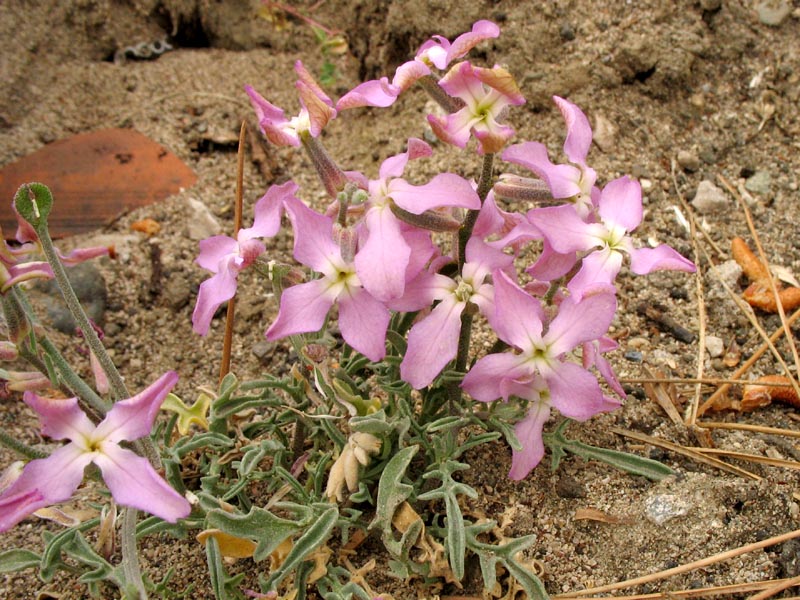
[0,0,800,599]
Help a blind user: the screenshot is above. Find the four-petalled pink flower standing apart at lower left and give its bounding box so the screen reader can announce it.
[0,371,191,531]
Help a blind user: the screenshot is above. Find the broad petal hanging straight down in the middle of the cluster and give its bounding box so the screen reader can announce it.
[354,206,411,302]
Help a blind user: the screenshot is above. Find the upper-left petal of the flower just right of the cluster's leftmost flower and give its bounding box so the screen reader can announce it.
[286,197,341,274]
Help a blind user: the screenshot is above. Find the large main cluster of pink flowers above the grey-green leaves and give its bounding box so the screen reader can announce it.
[194,21,694,479]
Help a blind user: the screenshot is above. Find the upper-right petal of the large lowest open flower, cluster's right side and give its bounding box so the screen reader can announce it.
[544,293,617,357]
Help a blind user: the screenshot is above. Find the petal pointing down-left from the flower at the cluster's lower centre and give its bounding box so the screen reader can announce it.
[400,296,465,389]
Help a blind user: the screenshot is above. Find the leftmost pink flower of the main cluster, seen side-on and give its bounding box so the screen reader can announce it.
[192,181,299,335]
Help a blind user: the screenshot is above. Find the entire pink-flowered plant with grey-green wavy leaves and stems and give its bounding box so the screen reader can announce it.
[0,21,694,600]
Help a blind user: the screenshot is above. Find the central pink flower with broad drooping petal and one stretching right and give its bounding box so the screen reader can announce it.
[355,138,481,302]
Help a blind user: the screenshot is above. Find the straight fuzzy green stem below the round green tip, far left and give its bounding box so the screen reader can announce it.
[36,227,130,400]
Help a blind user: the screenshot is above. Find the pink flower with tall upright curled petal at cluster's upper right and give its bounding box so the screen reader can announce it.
[503,96,597,217]
